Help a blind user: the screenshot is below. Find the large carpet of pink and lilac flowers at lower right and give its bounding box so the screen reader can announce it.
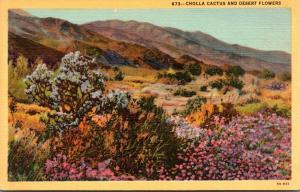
[160,113,291,180]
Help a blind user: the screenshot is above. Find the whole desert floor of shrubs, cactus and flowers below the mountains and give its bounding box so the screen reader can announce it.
[9,52,291,181]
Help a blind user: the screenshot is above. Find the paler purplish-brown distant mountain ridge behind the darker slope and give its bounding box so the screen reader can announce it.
[82,20,291,72]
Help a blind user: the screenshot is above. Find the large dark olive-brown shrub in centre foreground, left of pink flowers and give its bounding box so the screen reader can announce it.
[107,97,180,179]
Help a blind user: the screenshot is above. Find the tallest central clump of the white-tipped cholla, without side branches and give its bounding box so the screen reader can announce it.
[52,52,104,113]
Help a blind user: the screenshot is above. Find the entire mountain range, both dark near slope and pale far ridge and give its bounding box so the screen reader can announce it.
[8,10,291,72]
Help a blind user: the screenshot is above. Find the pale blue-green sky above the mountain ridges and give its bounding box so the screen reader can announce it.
[25,8,291,53]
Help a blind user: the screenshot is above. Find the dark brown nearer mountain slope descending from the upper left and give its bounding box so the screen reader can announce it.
[9,11,178,69]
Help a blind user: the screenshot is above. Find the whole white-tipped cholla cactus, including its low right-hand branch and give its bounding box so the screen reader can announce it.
[26,51,129,136]
